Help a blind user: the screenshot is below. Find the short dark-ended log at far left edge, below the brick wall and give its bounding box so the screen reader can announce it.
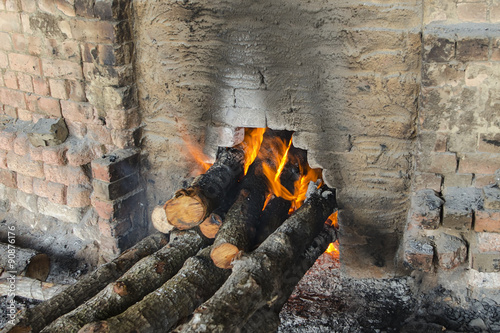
[0,243,50,281]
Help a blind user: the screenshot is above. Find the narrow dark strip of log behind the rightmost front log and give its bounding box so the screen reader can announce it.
[241,224,337,333]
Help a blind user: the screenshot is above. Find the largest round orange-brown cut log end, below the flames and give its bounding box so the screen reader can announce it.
[165,195,207,230]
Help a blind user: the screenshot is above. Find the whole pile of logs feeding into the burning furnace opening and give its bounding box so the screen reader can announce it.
[2,128,336,333]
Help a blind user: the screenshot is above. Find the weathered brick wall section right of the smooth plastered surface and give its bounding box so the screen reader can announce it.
[405,1,500,273]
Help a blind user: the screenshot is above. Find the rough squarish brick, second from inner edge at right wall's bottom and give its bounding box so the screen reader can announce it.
[434,233,467,269]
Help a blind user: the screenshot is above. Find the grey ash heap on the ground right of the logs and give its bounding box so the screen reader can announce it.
[278,254,500,333]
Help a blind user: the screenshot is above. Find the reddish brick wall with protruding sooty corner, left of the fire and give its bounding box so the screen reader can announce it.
[0,0,144,259]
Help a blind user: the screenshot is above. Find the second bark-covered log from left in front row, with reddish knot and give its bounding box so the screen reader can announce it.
[42,229,209,333]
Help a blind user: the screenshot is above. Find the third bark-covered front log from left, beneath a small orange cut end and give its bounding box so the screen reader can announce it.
[79,247,230,333]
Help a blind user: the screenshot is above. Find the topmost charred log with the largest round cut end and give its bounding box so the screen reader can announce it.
[164,144,245,230]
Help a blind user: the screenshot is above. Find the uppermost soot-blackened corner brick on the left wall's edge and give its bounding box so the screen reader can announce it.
[92,149,139,182]
